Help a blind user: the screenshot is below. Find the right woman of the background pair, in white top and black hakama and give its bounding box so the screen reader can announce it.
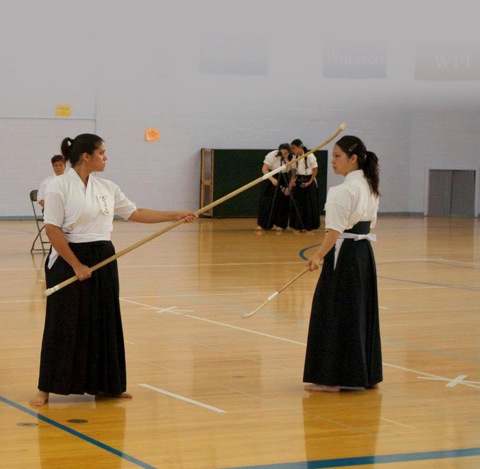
[289,138,320,232]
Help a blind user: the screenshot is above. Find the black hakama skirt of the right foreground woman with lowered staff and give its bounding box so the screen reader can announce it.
[303,222,383,387]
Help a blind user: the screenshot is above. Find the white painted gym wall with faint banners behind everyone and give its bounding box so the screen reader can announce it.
[0,0,480,217]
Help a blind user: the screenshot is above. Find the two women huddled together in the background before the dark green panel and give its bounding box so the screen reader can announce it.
[255,139,320,232]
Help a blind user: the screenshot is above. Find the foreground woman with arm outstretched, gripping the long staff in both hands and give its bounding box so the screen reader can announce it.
[30,134,197,406]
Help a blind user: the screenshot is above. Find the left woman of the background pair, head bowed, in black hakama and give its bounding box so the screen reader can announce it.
[255,143,292,231]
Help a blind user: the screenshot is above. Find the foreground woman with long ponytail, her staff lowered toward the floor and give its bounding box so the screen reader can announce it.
[303,135,383,392]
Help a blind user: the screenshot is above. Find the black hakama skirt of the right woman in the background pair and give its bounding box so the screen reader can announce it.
[290,176,320,231]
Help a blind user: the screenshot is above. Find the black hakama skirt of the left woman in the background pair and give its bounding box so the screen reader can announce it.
[257,173,290,230]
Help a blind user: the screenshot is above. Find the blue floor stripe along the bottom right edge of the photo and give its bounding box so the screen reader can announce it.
[225,448,480,469]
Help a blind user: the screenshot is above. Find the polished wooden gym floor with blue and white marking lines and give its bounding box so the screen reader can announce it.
[0,216,480,469]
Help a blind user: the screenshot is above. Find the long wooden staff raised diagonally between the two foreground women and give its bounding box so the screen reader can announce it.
[43,124,346,296]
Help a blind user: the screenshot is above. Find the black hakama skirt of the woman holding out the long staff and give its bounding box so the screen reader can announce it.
[38,241,127,395]
